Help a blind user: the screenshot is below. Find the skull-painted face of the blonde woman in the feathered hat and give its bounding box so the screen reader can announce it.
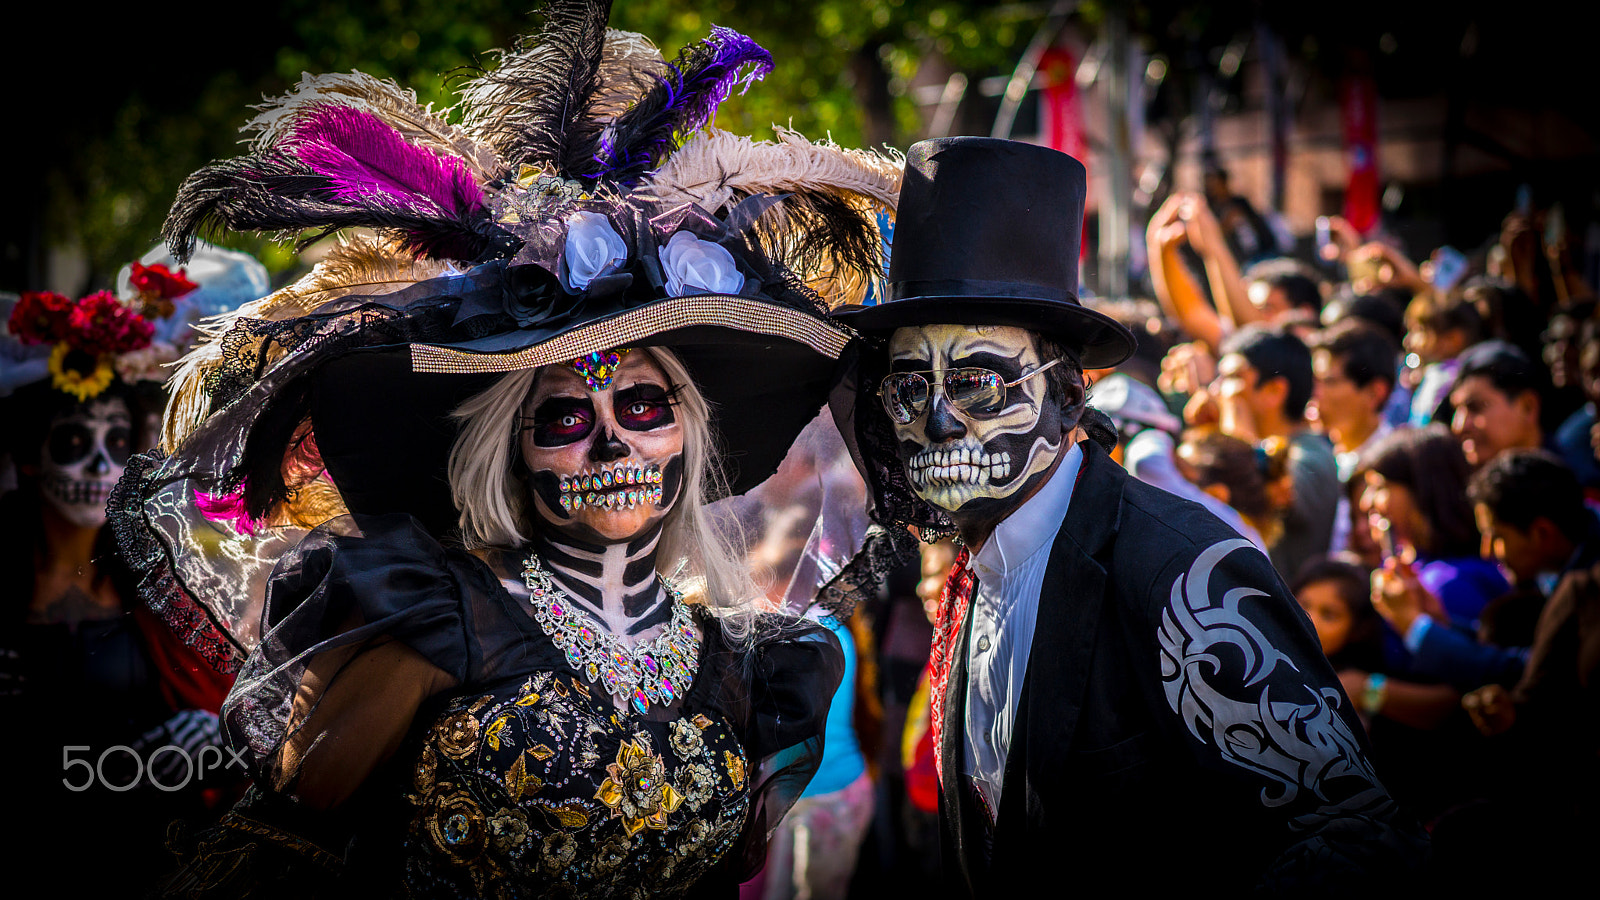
[522,351,683,544]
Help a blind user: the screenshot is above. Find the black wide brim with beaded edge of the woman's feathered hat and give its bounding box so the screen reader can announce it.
[300,264,853,533]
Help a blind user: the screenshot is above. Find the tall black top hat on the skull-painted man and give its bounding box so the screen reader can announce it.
[835,138,1134,368]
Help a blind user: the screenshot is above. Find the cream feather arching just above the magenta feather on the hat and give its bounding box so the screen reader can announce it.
[245,72,506,184]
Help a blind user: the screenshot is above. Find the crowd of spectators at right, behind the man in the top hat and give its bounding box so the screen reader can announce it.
[1062,184,1600,884]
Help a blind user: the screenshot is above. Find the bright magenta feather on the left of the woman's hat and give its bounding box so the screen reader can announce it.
[283,106,483,216]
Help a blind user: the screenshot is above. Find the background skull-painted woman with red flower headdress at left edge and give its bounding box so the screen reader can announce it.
[0,247,266,889]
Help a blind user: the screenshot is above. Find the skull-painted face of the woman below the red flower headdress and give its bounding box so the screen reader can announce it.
[38,399,133,528]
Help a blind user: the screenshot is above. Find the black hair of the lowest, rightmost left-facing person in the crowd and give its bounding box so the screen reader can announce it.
[1467,450,1594,544]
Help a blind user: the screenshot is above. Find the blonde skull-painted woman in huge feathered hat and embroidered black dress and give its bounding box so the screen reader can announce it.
[112,2,899,897]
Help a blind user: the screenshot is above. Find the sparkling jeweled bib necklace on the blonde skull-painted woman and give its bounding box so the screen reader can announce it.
[522,554,699,713]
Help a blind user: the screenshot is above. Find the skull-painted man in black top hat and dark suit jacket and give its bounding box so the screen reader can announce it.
[835,138,1426,897]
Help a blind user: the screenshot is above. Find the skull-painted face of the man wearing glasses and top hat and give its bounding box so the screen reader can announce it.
[890,325,1064,525]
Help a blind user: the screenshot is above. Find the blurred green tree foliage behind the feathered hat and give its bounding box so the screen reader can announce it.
[34,0,1048,287]
